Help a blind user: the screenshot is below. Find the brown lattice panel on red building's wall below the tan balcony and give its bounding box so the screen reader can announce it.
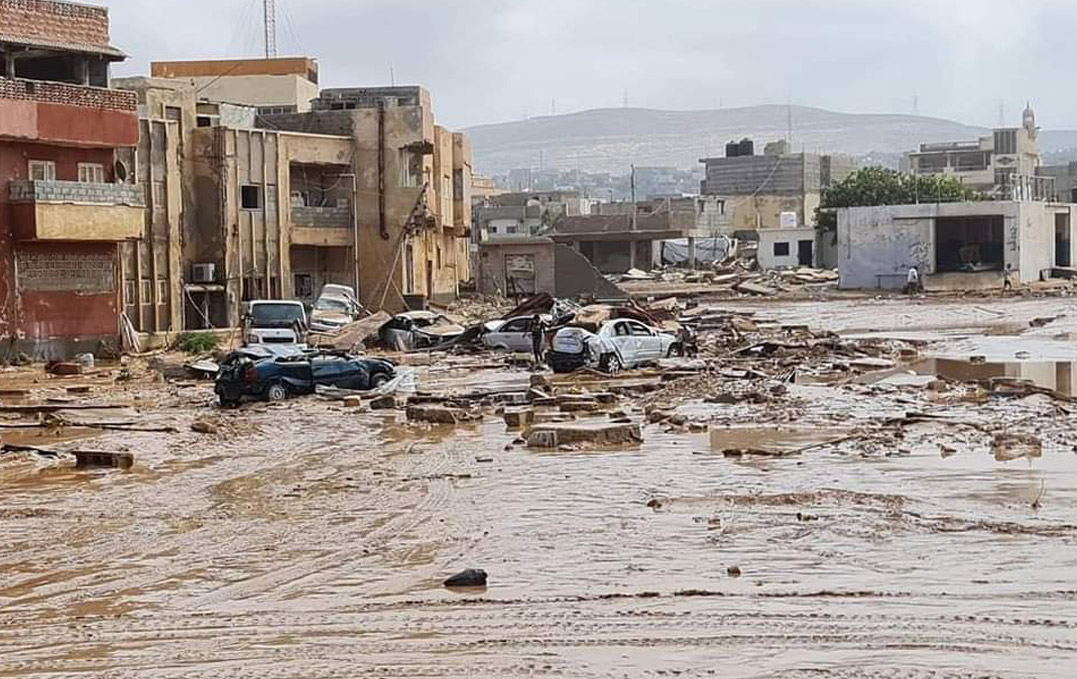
[15,250,116,293]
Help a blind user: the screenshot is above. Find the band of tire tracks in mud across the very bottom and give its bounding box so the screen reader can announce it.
[0,596,1077,679]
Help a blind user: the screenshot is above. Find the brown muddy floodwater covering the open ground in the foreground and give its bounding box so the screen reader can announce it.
[0,300,1077,679]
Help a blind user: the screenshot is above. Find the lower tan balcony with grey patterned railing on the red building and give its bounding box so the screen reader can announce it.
[8,181,145,243]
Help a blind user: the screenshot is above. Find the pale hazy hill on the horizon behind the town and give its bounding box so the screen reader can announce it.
[467,106,1077,175]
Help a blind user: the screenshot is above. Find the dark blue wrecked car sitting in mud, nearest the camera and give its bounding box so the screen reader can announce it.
[213,346,396,407]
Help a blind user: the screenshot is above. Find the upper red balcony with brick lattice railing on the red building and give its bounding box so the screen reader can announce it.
[0,78,139,149]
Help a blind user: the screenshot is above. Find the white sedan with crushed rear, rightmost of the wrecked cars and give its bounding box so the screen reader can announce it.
[546,318,684,374]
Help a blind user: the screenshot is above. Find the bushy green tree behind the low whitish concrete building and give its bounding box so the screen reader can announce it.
[815,167,984,232]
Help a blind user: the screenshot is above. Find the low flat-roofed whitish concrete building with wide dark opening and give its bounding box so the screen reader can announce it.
[838,202,1077,290]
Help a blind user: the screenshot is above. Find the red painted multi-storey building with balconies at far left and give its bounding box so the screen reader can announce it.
[0,0,145,358]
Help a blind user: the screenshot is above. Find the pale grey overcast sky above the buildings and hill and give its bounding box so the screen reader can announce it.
[105,0,1077,129]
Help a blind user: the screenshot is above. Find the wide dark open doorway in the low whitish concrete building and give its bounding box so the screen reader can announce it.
[935,214,1005,273]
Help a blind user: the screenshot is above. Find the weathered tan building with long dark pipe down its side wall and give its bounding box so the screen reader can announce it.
[263,86,471,309]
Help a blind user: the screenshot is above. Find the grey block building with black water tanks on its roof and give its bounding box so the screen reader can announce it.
[700,143,856,233]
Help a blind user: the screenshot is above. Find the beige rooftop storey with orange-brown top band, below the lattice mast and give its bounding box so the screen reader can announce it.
[150,57,318,114]
